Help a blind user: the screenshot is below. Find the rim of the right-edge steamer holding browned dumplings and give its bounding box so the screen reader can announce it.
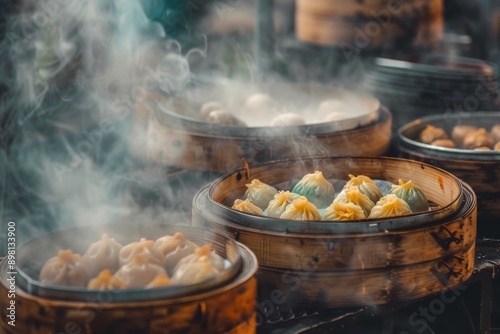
[397,111,500,162]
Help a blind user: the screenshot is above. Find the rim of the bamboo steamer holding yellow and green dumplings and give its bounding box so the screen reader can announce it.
[203,157,464,236]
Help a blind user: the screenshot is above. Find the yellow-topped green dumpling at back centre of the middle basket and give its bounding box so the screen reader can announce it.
[292,171,335,209]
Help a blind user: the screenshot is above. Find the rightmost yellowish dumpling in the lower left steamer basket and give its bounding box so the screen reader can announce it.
[172,245,224,284]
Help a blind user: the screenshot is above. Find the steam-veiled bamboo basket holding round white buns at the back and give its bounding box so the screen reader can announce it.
[147,80,392,172]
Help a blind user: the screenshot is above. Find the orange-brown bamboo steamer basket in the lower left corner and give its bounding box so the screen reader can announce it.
[0,222,257,334]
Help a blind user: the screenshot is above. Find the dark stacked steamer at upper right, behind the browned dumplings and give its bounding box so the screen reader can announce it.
[364,56,497,130]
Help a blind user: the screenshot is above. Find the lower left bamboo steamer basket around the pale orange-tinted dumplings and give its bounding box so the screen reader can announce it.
[0,223,257,334]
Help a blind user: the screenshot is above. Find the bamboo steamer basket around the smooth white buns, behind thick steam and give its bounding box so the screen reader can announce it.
[147,82,392,172]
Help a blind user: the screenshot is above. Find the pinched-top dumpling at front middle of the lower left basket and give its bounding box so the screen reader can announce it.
[115,253,167,289]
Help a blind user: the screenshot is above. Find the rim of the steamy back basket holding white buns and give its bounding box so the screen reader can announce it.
[149,89,383,138]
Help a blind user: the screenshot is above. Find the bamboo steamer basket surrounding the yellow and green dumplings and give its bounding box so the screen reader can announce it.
[193,157,477,308]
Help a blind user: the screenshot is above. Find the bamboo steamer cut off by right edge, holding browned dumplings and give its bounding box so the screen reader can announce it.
[397,112,500,237]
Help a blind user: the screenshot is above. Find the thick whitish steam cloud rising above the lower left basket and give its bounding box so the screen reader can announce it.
[0,0,203,250]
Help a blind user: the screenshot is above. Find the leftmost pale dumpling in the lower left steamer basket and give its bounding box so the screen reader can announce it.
[39,249,89,287]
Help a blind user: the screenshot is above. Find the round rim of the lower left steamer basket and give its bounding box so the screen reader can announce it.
[10,223,257,304]
